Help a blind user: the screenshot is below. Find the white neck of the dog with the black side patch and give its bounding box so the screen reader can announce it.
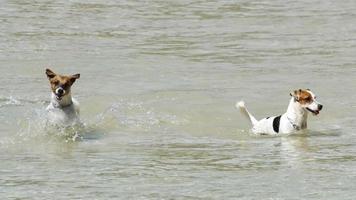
[286,97,308,128]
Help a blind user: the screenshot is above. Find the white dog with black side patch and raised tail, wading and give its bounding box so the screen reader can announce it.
[236,89,323,135]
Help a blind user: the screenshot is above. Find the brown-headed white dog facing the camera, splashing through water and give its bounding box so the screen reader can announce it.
[46,69,80,126]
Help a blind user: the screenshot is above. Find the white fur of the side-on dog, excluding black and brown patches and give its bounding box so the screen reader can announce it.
[236,92,319,135]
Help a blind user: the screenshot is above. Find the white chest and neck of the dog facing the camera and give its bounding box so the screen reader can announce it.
[46,92,80,126]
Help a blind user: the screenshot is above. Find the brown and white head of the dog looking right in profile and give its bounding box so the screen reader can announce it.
[290,89,323,115]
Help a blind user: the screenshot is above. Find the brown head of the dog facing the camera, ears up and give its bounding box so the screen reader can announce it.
[46,69,80,100]
